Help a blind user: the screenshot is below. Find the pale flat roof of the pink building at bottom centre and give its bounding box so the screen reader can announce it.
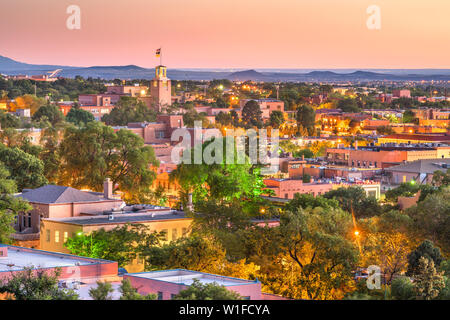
[127,269,258,287]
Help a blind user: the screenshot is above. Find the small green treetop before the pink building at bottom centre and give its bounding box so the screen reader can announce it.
[174,279,241,300]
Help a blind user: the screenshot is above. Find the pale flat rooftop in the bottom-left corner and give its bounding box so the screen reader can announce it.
[0,245,111,272]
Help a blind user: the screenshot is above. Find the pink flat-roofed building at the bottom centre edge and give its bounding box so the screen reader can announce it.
[123,269,264,300]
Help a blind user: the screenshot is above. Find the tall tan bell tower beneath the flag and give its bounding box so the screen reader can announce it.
[150,65,172,112]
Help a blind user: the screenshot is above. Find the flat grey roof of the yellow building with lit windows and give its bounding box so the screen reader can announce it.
[44,210,190,226]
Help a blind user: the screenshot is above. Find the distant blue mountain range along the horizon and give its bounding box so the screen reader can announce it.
[0,56,450,82]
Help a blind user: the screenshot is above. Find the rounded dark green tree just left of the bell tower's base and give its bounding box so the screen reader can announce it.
[102,96,156,126]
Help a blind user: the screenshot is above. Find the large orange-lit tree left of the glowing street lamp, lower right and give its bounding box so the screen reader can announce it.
[280,208,358,300]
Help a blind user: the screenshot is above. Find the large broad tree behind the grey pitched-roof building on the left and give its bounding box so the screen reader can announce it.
[58,122,159,202]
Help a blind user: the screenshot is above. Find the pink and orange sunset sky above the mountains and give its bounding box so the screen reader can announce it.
[0,0,450,69]
